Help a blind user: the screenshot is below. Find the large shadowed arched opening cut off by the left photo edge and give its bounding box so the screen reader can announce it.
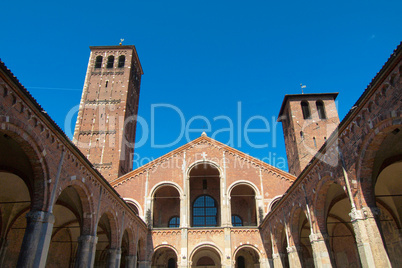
[0,132,37,267]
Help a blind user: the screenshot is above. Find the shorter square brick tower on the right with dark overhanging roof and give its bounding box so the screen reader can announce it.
[278,93,339,176]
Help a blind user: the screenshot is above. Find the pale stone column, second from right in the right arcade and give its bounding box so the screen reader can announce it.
[309,233,333,268]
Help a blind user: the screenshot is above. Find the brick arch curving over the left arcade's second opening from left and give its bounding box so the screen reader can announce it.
[53,180,96,235]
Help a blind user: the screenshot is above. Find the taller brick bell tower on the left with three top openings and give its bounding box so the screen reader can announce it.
[73,45,143,182]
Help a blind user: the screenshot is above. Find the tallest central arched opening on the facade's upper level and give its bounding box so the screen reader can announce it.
[189,163,221,227]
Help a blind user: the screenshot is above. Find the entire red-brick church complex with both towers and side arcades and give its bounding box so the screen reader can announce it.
[0,45,402,268]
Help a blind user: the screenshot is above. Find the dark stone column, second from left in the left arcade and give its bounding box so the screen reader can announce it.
[75,235,98,268]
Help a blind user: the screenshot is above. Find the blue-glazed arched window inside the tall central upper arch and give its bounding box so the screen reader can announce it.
[193,195,218,227]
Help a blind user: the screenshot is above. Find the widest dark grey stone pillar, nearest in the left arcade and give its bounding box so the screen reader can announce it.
[17,211,54,267]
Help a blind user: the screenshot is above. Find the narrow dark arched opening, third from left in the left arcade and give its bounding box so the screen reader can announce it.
[94,214,112,267]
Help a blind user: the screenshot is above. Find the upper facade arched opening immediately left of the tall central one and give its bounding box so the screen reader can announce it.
[153,186,180,228]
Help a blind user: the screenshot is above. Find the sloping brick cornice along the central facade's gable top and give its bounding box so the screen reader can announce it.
[110,135,296,186]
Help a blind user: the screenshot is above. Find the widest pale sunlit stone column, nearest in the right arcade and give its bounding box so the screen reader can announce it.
[349,207,392,267]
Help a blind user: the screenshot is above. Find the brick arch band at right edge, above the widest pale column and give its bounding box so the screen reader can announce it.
[356,118,402,206]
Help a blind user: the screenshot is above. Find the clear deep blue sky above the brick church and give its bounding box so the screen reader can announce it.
[0,0,402,170]
